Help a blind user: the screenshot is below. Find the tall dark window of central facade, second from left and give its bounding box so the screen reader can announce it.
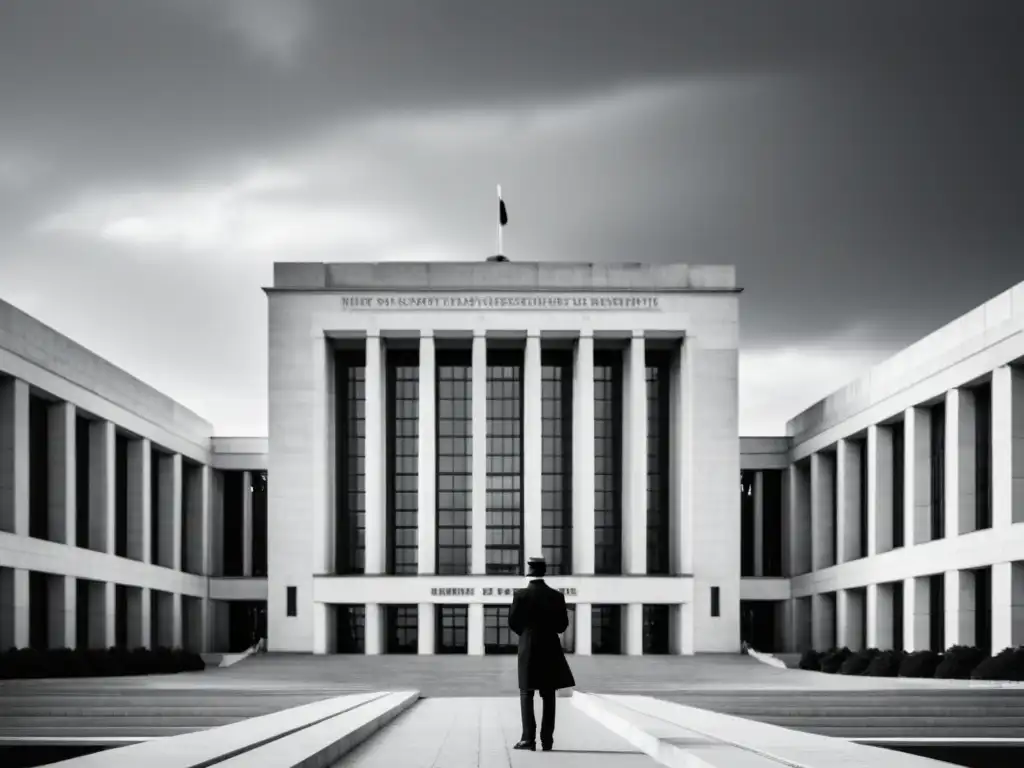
[386,350,420,575]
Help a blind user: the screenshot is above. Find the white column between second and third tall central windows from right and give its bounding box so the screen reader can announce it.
[572,332,594,573]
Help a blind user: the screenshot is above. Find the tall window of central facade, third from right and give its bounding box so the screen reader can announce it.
[541,350,572,575]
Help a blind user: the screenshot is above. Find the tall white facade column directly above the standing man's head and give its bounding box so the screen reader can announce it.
[522,331,544,565]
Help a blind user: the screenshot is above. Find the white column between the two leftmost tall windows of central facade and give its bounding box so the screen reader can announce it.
[365,333,387,573]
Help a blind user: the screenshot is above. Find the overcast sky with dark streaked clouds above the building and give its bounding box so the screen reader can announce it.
[0,0,1024,434]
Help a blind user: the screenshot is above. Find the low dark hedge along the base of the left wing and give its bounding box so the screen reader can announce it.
[0,648,206,680]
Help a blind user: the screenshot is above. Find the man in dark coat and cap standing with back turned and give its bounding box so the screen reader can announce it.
[509,557,575,752]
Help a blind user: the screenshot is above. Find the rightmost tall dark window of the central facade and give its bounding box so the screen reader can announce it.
[645,351,672,574]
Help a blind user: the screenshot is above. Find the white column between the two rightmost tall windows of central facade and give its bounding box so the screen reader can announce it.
[623,331,647,574]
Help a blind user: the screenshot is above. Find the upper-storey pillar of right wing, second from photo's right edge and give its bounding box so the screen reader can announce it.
[945,389,978,536]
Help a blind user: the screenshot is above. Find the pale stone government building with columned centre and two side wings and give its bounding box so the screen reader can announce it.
[0,260,1024,655]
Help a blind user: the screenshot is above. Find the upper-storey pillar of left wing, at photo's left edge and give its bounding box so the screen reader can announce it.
[0,379,29,536]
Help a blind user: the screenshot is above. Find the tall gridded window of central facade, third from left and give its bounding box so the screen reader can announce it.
[437,349,473,573]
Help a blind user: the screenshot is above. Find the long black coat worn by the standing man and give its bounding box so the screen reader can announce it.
[509,579,575,691]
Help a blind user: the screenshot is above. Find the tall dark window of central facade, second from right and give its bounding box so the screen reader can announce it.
[594,350,623,573]
